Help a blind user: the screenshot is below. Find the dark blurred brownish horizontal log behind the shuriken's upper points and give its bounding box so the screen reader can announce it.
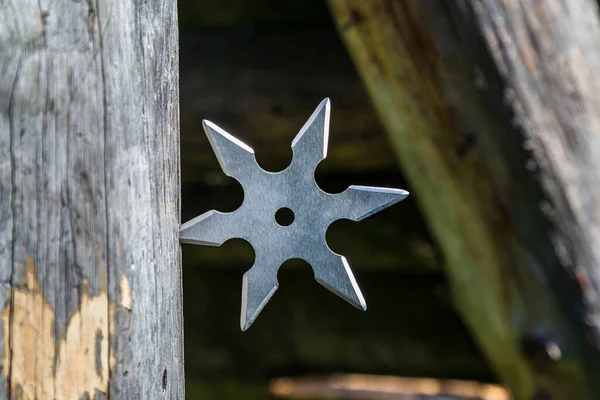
[181,28,398,188]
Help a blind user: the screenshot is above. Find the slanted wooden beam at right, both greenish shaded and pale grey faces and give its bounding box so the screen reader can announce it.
[330,0,600,399]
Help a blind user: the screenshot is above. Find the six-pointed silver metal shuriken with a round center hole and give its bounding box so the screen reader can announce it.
[180,99,408,331]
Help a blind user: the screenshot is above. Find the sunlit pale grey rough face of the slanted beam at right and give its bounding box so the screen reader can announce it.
[458,0,600,349]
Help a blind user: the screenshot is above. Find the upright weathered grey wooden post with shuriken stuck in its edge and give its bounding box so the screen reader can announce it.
[0,0,184,399]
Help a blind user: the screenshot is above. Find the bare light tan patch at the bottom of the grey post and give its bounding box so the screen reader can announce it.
[1,259,109,400]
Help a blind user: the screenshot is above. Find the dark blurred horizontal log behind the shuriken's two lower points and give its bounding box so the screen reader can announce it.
[183,268,493,382]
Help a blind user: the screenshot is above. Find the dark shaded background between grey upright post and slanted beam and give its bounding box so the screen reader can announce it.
[179,0,493,399]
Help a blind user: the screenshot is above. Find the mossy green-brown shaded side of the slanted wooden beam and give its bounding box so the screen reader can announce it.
[329,0,587,400]
